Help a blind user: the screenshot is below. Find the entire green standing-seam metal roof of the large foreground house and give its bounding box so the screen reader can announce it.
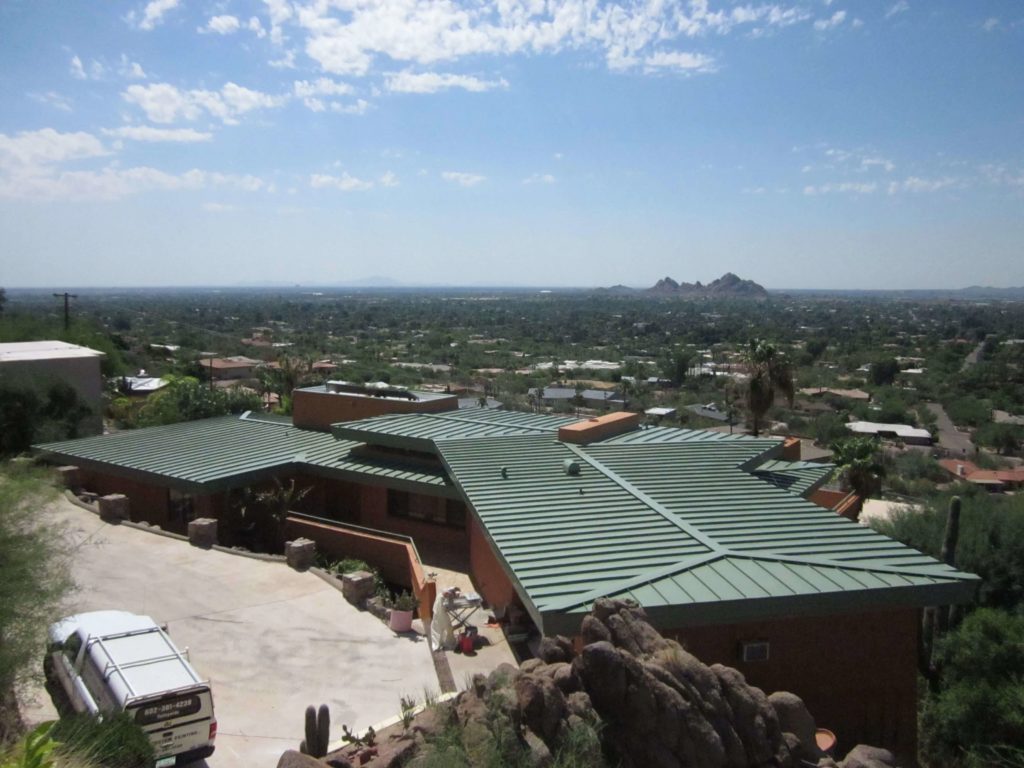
[36,410,978,632]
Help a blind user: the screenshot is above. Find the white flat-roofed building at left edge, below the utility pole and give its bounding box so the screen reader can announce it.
[0,341,103,435]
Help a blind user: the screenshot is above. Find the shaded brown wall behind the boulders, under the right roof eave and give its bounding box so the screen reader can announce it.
[663,608,920,765]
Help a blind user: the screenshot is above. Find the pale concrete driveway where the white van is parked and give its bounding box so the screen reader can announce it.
[27,498,438,768]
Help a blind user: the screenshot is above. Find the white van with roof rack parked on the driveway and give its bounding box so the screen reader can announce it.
[45,610,217,768]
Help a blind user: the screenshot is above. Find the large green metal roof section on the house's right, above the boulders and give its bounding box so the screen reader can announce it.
[437,429,977,632]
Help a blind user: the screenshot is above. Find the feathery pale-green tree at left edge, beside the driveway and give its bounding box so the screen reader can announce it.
[0,463,71,716]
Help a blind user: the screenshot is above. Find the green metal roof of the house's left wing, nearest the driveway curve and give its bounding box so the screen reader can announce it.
[35,414,454,496]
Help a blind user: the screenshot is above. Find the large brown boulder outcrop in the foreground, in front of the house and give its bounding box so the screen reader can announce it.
[279,600,895,768]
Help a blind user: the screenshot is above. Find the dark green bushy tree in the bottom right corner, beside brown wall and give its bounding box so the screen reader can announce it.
[921,609,1024,768]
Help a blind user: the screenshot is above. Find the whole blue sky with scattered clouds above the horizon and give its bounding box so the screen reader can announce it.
[0,0,1024,288]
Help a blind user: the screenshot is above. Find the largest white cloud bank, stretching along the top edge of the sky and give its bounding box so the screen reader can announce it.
[292,0,810,76]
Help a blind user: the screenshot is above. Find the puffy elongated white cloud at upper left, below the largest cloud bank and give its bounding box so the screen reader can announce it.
[121,83,287,123]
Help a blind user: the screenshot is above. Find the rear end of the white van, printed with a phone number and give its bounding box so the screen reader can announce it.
[127,686,217,768]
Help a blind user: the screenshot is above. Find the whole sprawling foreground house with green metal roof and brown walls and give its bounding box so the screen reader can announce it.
[37,405,978,756]
